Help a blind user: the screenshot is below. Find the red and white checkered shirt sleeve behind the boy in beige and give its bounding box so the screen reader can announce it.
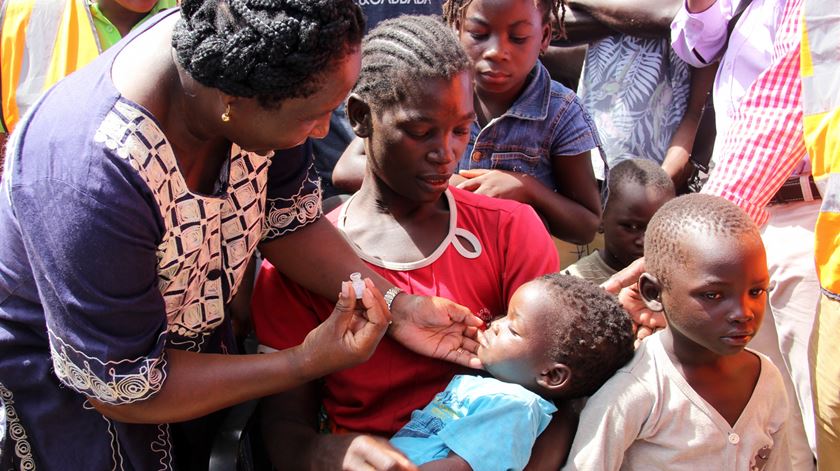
[702,0,806,226]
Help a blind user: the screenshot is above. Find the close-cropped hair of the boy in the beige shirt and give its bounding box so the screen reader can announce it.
[645,194,761,288]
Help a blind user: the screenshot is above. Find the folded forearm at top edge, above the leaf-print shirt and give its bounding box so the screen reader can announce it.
[568,0,682,38]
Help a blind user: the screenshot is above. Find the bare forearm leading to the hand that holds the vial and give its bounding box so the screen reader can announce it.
[90,347,316,424]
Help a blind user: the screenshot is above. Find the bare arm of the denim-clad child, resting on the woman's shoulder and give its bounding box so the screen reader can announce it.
[458,151,601,244]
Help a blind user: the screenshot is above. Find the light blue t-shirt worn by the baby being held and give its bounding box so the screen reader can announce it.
[391,375,557,471]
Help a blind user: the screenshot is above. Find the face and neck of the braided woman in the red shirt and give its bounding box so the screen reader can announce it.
[344,71,475,263]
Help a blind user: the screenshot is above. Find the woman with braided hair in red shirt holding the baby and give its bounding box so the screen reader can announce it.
[252,16,559,470]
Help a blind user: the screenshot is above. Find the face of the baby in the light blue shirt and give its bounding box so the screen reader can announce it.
[478,281,557,393]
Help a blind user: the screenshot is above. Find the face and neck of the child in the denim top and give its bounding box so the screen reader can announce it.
[457,0,551,124]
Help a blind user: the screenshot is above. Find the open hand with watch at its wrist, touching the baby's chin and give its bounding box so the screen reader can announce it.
[390,293,484,368]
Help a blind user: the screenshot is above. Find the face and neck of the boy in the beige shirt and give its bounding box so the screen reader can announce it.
[639,233,769,425]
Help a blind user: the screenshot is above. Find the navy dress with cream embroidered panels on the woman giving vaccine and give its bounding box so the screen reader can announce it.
[0,10,321,471]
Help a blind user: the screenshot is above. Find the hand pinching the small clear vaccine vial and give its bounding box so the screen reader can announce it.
[300,278,391,378]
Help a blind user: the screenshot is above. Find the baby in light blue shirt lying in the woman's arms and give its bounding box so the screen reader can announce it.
[391,273,633,471]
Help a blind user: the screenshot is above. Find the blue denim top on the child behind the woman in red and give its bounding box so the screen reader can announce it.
[458,62,600,191]
